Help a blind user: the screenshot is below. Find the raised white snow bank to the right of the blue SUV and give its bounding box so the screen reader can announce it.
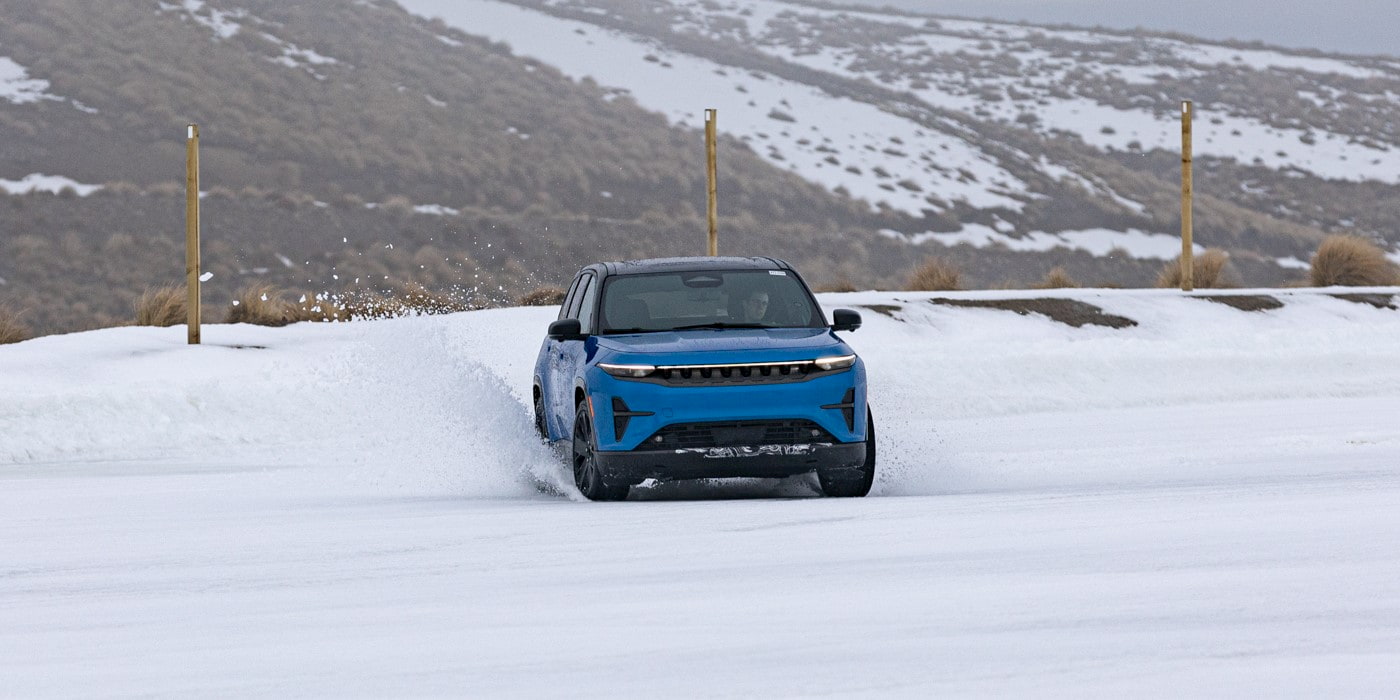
[823,290,1400,494]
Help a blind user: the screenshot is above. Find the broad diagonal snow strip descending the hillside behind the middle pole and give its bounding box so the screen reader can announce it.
[399,0,1028,216]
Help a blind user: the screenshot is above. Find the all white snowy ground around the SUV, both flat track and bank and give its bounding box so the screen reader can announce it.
[0,290,1400,697]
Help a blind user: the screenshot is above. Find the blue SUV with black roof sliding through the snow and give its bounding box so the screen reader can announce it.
[533,258,875,500]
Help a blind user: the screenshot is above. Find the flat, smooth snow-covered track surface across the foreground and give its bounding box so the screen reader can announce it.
[0,431,1400,696]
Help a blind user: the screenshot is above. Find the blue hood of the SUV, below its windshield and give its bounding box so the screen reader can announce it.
[594,328,851,364]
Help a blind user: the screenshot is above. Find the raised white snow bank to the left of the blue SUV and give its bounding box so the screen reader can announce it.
[0,310,568,497]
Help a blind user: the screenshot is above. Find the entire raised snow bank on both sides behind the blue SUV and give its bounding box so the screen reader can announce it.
[0,290,1400,497]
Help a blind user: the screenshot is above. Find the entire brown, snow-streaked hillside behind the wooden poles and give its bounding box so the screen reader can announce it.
[0,0,1400,335]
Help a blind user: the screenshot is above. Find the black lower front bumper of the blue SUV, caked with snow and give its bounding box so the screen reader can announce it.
[594,442,865,483]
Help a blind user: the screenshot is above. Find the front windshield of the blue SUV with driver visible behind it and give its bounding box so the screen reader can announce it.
[599,270,825,333]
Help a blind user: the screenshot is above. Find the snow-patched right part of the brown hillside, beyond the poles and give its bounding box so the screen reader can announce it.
[400,0,1400,265]
